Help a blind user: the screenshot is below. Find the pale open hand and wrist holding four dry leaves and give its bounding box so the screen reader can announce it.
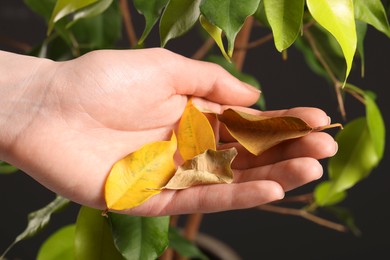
[0,48,337,216]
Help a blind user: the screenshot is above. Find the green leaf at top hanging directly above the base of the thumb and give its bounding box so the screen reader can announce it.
[160,0,201,46]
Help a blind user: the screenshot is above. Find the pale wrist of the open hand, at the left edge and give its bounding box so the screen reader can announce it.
[0,51,54,163]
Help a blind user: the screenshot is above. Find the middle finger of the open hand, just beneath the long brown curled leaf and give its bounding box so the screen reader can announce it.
[222,133,338,169]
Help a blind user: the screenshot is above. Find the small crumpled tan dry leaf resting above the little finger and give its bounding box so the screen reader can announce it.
[164,147,237,190]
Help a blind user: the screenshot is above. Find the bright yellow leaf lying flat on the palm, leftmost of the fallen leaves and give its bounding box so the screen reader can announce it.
[104,134,177,210]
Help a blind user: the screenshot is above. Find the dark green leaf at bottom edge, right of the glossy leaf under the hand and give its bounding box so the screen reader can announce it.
[169,227,208,260]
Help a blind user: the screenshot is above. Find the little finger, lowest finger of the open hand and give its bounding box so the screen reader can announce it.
[125,180,284,216]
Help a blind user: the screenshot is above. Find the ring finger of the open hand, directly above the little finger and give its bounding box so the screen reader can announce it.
[234,157,323,191]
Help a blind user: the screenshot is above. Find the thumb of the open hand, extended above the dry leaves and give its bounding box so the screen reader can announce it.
[160,48,260,106]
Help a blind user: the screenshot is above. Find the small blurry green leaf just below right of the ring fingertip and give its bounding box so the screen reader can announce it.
[314,181,347,207]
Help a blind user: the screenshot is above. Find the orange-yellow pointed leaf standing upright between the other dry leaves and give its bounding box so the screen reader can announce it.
[177,99,216,161]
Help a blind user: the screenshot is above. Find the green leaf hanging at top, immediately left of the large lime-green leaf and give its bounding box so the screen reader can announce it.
[263,0,305,52]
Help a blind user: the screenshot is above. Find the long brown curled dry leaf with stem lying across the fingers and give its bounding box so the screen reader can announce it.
[218,109,341,155]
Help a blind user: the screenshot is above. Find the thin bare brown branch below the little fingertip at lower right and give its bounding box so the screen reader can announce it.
[257,204,348,233]
